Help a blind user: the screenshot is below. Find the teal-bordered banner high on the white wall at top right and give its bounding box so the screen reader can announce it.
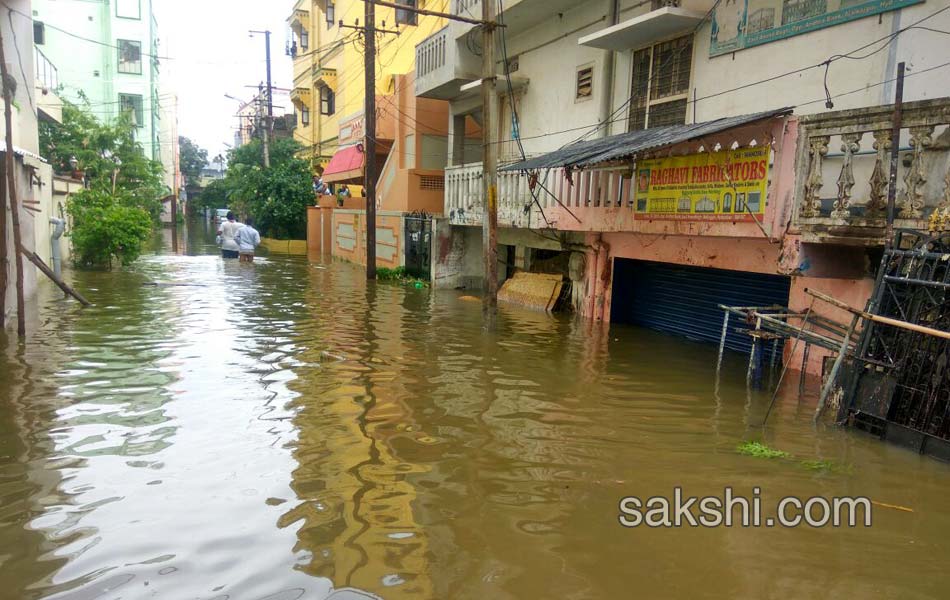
[709,0,924,56]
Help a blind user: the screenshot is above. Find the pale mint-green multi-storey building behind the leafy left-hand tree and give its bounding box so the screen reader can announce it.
[32,0,167,165]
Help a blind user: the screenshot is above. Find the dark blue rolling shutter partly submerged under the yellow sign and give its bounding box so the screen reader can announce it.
[610,258,791,352]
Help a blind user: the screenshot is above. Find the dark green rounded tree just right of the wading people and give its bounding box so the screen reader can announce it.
[223,139,314,239]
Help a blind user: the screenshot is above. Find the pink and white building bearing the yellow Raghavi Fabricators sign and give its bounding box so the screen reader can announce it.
[415,0,950,372]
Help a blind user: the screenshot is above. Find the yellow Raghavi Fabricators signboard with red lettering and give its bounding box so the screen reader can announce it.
[636,146,769,221]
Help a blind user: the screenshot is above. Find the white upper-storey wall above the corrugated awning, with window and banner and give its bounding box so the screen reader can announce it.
[415,0,950,159]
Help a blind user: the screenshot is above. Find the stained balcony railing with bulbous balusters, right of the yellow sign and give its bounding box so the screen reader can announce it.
[796,98,950,245]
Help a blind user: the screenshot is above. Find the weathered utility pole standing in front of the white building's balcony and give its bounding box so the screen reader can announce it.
[482,0,498,328]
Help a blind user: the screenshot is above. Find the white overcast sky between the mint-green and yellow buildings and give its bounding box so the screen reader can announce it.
[153,0,293,163]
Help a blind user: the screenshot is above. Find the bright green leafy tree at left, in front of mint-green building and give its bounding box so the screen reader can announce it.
[40,101,168,266]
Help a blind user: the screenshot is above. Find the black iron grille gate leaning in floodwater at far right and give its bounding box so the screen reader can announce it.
[839,231,950,458]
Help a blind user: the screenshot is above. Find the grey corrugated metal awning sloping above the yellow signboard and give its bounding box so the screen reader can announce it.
[500,108,792,171]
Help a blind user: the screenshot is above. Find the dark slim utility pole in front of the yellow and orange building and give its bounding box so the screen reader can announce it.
[363,0,376,281]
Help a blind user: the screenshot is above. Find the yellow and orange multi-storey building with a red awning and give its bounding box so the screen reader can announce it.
[287,0,478,268]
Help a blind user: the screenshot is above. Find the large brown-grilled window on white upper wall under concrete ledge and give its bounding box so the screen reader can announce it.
[629,35,693,131]
